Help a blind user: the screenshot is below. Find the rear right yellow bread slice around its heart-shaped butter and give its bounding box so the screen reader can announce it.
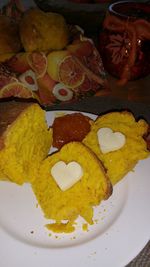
[83,111,150,184]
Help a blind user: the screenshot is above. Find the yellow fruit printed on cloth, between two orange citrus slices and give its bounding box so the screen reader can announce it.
[47,50,69,82]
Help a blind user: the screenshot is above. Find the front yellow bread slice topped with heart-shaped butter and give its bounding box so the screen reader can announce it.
[32,142,112,232]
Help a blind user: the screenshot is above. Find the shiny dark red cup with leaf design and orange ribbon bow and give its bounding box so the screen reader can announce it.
[99,1,150,83]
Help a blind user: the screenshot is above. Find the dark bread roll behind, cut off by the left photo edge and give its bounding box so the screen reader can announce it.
[0,15,22,54]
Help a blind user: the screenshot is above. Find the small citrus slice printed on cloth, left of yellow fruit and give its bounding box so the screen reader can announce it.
[27,52,47,78]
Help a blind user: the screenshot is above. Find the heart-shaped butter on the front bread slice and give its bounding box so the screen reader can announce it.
[51,161,83,191]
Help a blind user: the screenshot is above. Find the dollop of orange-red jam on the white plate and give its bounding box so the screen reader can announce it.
[52,113,91,149]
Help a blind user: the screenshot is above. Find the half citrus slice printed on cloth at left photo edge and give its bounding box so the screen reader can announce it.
[0,82,38,100]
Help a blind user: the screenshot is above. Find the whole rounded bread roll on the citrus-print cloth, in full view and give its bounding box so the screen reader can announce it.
[20,8,69,52]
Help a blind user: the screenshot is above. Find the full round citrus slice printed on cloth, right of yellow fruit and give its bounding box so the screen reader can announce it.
[59,55,85,88]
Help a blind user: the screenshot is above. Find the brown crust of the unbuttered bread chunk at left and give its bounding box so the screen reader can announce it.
[0,101,33,149]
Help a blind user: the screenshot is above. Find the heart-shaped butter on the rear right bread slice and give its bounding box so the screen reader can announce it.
[97,128,126,154]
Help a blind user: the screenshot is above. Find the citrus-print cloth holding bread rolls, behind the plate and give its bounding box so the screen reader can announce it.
[0,1,109,107]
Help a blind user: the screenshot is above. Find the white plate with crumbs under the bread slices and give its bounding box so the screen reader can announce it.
[0,111,150,267]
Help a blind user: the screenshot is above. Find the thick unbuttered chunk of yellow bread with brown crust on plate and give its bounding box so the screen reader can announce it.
[0,101,52,184]
